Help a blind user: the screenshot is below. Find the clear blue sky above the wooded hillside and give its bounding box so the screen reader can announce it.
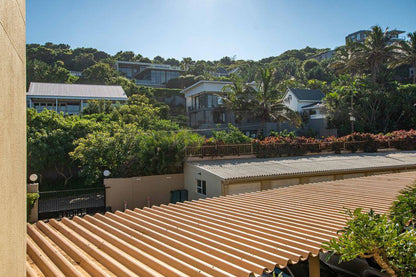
[26,0,416,60]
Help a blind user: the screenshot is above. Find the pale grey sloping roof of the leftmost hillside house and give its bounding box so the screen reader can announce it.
[26,82,127,100]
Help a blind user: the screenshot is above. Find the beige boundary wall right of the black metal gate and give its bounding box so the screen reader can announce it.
[104,174,184,211]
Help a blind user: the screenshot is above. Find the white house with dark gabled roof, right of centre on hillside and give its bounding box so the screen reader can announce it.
[283,88,336,137]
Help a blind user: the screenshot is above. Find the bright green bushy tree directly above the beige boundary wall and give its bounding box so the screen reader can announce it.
[70,125,202,184]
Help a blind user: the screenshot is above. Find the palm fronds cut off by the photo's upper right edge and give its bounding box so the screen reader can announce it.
[390,32,416,84]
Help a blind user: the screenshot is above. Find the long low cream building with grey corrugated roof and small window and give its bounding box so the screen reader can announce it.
[184,151,416,200]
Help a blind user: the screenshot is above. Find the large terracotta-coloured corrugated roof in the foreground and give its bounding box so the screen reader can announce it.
[27,171,416,276]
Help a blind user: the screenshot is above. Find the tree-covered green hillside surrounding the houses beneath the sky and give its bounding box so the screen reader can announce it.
[27,26,416,187]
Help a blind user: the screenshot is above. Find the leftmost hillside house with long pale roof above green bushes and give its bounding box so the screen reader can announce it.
[26,82,128,115]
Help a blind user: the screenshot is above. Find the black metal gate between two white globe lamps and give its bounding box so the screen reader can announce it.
[38,187,106,220]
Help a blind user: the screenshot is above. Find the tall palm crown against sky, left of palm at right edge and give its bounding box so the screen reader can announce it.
[357,26,394,81]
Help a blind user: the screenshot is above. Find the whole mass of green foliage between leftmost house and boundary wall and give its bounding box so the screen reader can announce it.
[27,95,202,190]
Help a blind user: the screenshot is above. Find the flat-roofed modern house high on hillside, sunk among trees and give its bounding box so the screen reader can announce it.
[116,61,184,87]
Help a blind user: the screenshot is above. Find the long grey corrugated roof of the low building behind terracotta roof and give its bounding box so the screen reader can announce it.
[190,151,416,180]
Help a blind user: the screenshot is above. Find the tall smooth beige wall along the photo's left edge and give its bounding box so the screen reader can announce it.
[0,0,26,276]
